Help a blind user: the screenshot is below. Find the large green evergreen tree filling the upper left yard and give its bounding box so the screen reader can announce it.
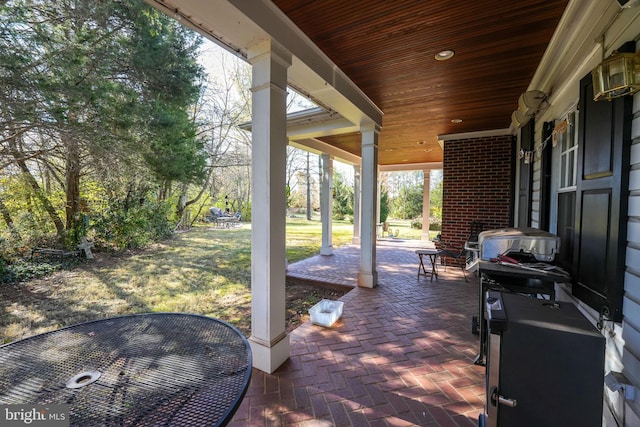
[0,0,204,244]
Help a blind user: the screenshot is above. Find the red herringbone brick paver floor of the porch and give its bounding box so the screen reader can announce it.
[230,240,485,427]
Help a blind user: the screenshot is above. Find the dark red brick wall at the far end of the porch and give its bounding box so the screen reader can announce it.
[442,135,513,249]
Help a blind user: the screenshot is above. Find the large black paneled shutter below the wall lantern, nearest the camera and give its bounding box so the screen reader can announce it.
[573,70,633,321]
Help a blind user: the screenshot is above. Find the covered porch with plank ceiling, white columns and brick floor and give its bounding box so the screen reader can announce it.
[142,0,640,426]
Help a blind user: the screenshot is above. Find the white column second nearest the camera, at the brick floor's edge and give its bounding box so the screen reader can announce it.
[358,124,380,288]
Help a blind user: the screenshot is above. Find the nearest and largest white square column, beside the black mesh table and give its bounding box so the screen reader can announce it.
[249,41,291,373]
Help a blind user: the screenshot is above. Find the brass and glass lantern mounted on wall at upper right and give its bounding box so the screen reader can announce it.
[591,53,640,101]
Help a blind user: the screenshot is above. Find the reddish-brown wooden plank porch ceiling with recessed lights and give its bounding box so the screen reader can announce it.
[274,0,568,165]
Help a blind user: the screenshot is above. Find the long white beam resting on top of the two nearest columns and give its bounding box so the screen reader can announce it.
[145,0,383,130]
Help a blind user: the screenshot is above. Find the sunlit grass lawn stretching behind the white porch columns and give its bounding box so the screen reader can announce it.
[0,215,436,343]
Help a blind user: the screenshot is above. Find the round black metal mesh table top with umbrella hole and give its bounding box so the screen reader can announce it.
[0,313,252,427]
